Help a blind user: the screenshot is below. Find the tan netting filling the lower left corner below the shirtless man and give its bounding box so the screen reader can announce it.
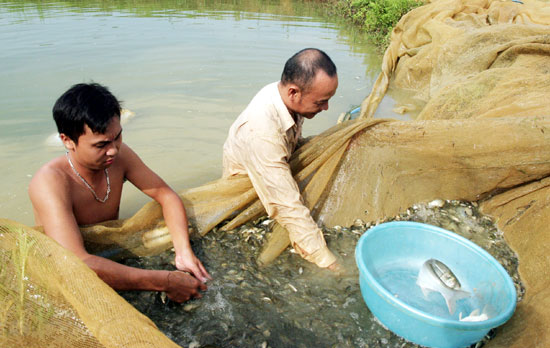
[0,219,178,348]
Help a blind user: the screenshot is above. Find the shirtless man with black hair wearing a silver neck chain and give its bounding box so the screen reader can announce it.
[29,84,210,302]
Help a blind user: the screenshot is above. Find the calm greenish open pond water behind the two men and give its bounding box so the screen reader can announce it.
[0,0,406,225]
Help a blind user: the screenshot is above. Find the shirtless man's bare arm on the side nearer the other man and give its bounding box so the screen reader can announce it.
[121,144,212,282]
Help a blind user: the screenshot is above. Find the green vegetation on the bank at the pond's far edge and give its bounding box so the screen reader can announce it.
[330,0,423,49]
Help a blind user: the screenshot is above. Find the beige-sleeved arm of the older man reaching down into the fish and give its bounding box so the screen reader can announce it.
[241,134,336,267]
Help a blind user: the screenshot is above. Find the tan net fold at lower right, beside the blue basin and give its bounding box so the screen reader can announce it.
[481,178,550,348]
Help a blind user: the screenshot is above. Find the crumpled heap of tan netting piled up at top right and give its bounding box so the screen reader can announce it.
[361,0,550,119]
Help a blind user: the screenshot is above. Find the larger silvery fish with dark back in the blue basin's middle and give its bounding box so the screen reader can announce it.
[416,259,470,314]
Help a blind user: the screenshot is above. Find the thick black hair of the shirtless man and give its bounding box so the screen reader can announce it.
[52,83,120,143]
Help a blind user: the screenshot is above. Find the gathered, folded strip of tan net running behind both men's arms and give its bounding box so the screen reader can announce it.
[76,120,387,263]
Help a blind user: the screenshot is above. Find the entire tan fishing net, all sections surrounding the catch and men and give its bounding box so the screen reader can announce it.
[0,0,550,347]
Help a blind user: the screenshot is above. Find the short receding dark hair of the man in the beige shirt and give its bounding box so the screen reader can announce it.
[281,48,336,90]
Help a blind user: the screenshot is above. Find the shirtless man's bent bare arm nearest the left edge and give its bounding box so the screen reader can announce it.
[29,168,206,302]
